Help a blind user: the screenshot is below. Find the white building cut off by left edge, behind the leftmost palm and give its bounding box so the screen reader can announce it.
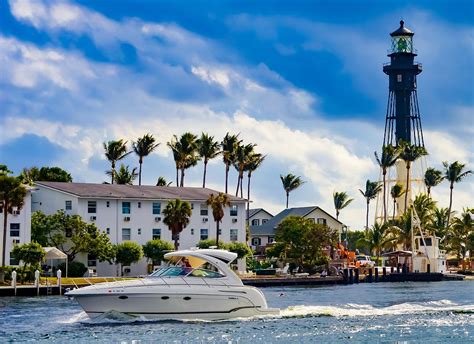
[0,189,31,265]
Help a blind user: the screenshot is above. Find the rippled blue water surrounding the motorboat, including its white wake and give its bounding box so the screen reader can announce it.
[0,281,474,344]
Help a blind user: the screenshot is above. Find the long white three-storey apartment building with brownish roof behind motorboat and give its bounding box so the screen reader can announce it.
[32,182,246,276]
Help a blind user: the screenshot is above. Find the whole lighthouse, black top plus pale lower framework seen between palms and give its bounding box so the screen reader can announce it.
[376,20,426,220]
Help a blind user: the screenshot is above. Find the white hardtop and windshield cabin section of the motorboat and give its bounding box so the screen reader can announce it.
[149,249,242,285]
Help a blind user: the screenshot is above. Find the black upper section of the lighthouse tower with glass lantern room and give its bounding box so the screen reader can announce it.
[383,20,424,147]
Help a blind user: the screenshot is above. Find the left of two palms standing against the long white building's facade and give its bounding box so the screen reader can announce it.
[163,198,191,250]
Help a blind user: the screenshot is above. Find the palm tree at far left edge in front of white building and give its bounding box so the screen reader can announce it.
[0,173,27,282]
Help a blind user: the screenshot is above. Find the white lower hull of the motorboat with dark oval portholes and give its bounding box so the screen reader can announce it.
[69,287,279,320]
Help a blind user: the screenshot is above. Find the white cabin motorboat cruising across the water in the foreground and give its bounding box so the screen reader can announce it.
[66,249,279,320]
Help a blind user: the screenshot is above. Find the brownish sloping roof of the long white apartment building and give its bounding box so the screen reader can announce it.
[36,182,246,202]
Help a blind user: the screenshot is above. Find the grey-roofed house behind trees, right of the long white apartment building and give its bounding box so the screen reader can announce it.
[250,206,343,252]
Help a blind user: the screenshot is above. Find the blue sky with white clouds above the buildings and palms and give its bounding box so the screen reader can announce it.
[0,0,474,228]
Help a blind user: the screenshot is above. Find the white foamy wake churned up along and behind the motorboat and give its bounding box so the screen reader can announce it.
[65,300,474,326]
